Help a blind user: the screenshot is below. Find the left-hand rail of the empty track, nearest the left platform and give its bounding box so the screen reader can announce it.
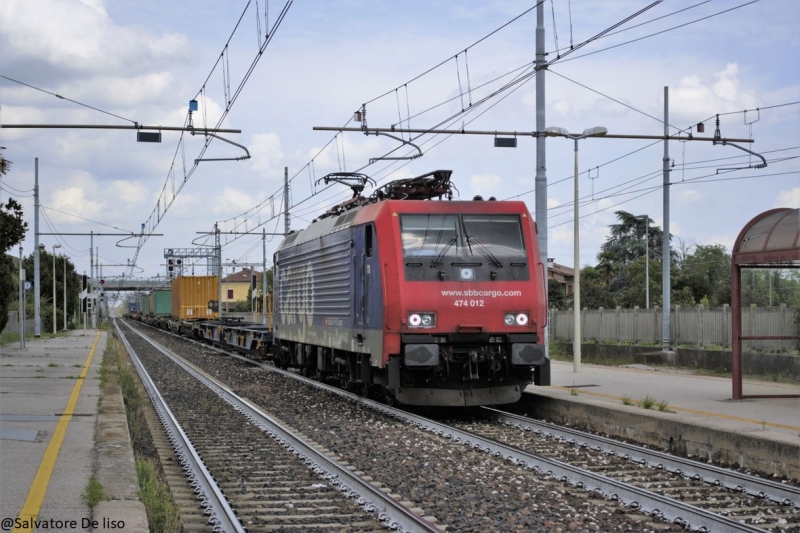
[114,319,245,533]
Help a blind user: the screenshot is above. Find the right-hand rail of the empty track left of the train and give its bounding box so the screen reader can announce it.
[122,320,442,533]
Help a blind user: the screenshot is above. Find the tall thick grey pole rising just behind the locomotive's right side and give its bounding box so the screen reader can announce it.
[534,2,548,356]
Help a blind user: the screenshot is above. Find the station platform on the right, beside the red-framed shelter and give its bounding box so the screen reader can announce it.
[525,361,800,479]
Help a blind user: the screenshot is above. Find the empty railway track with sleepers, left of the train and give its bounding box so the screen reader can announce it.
[117,320,439,532]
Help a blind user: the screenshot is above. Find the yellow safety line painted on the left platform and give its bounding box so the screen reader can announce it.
[14,332,102,532]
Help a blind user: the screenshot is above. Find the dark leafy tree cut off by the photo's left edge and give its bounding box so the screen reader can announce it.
[0,146,28,331]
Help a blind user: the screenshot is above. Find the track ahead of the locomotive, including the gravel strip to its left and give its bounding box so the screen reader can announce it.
[120,320,800,531]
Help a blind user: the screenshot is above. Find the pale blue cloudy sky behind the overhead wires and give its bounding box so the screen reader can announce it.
[0,0,800,290]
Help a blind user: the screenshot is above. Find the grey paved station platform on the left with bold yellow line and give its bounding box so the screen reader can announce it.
[0,330,148,532]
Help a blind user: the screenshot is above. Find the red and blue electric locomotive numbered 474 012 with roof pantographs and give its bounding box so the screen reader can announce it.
[273,170,550,406]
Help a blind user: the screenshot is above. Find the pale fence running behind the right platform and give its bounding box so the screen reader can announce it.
[549,305,798,352]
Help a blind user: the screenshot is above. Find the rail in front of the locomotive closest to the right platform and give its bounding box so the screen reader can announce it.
[481,407,800,507]
